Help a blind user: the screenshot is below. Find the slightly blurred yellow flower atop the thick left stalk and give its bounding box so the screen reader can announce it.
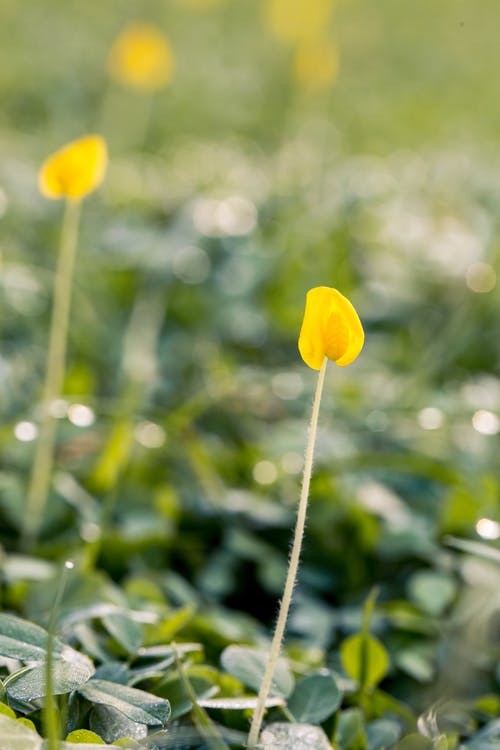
[38,135,108,201]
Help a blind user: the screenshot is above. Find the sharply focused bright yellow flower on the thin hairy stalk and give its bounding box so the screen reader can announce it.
[299,286,365,370]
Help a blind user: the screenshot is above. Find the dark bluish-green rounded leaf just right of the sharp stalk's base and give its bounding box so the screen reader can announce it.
[287,674,342,724]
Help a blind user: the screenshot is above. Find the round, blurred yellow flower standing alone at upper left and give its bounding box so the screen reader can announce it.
[108,23,174,91]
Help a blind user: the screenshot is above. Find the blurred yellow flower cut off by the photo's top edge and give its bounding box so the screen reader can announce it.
[264,0,333,42]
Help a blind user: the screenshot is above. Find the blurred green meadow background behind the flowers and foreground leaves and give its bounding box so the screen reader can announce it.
[0,0,500,740]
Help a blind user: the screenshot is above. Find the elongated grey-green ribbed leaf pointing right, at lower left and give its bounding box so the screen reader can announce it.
[79,679,170,726]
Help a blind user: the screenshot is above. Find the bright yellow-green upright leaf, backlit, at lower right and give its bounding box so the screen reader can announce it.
[340,634,389,687]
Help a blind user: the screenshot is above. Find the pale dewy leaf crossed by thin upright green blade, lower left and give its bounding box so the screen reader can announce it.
[5,649,95,703]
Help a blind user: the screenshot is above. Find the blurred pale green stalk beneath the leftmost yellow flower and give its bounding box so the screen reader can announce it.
[23,201,80,547]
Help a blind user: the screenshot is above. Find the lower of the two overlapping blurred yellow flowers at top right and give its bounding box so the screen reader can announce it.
[294,38,339,91]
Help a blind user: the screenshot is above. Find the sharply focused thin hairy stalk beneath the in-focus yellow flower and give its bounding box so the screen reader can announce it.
[247,357,328,750]
